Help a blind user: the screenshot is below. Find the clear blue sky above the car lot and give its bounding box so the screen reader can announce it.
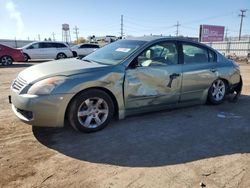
[0,0,250,40]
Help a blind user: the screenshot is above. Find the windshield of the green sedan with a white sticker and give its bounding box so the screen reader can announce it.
[82,40,145,65]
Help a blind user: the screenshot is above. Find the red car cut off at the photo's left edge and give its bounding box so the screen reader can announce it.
[0,44,25,66]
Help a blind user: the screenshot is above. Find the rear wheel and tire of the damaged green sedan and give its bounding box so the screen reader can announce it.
[208,79,227,105]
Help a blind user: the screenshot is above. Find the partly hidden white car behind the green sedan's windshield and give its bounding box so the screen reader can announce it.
[71,43,100,57]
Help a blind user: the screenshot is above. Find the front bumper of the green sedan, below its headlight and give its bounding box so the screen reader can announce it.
[11,90,73,127]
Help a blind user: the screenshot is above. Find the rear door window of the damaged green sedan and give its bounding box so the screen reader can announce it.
[183,44,209,64]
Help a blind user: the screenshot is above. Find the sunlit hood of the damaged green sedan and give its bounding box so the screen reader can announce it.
[18,58,108,83]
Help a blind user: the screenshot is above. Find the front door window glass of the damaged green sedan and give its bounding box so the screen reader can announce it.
[138,42,178,66]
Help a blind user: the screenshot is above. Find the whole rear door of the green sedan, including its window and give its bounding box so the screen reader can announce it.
[181,42,218,102]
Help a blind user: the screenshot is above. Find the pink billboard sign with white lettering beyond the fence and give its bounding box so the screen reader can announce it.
[199,25,225,42]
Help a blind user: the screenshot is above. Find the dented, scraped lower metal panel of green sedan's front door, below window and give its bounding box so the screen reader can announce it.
[124,64,182,109]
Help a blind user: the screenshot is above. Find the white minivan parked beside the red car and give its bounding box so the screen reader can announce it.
[21,41,73,61]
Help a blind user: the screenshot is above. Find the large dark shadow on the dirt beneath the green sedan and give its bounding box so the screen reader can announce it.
[33,95,250,167]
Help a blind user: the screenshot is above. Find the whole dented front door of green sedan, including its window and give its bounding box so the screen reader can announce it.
[124,42,182,109]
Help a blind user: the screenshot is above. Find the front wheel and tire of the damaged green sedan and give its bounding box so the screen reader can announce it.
[67,89,114,133]
